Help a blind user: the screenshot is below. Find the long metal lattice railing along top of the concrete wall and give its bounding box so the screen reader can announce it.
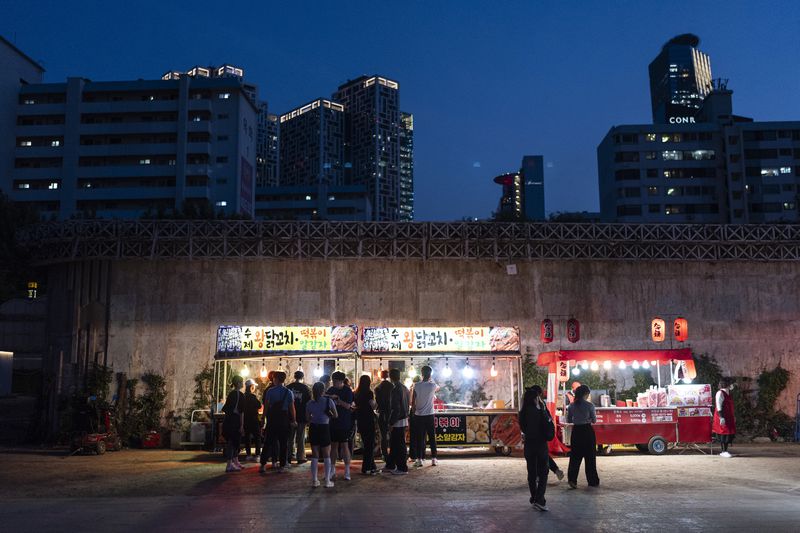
[17,220,800,264]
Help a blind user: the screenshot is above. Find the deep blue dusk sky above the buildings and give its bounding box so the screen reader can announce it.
[0,0,800,220]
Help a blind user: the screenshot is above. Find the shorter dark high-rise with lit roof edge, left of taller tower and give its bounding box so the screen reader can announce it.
[280,98,344,186]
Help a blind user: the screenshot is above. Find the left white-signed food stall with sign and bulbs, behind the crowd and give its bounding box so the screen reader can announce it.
[212,326,358,448]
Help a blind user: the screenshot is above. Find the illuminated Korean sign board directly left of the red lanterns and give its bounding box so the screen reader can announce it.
[362,327,520,353]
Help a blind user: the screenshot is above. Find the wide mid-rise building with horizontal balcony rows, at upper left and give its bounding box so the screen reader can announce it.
[10,65,257,219]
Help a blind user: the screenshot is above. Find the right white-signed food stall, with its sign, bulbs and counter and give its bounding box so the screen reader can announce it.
[359,326,522,455]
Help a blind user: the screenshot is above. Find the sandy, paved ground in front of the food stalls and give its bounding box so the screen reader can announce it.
[0,444,800,533]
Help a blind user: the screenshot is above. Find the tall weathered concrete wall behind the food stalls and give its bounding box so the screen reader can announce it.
[101,259,800,415]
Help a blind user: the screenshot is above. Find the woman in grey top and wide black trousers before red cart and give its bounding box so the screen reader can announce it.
[567,385,600,489]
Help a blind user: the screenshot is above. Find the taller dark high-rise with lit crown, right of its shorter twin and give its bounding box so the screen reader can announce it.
[333,76,400,221]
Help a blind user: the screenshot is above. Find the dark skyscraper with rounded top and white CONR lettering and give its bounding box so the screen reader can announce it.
[649,33,712,124]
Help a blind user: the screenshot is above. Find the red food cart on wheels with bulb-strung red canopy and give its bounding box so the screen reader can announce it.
[537,348,711,455]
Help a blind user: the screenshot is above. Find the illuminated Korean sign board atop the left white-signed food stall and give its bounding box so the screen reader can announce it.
[217,326,358,354]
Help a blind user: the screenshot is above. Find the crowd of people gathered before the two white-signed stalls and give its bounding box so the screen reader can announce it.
[222,366,438,487]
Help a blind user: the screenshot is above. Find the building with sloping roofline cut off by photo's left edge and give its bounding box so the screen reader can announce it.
[0,37,45,194]
